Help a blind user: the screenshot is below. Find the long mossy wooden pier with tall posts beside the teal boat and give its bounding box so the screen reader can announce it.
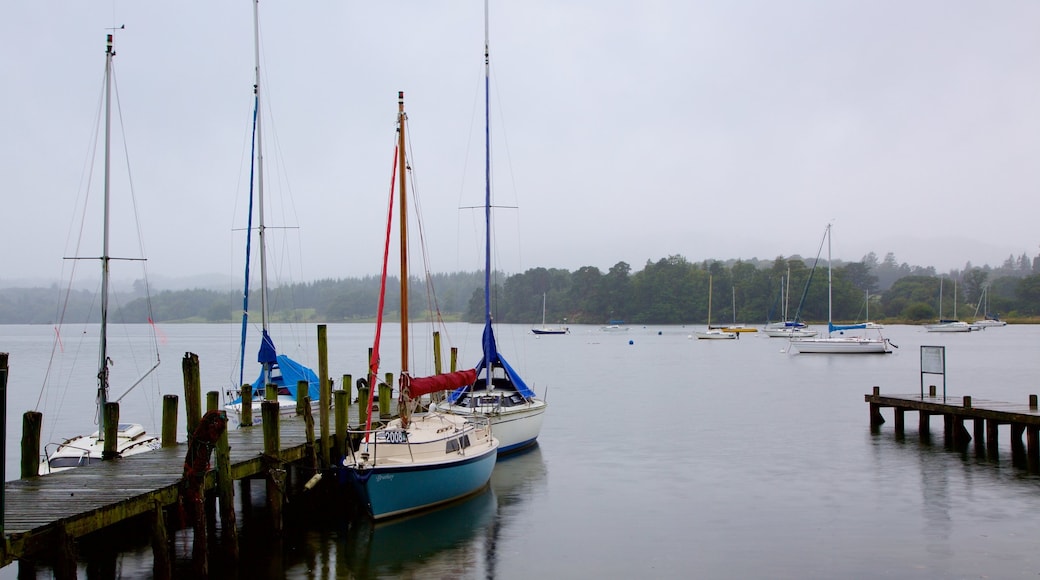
[0,332,418,579]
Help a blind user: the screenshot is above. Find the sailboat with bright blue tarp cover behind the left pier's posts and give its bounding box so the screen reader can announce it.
[224,0,320,425]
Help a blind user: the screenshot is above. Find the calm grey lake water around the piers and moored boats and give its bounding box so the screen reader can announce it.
[0,324,1040,579]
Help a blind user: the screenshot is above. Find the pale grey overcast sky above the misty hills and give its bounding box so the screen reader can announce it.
[0,0,1040,286]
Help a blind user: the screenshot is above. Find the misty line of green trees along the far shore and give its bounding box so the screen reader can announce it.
[6,254,1040,324]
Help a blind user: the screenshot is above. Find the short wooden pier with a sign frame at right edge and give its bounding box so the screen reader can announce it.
[864,387,1040,473]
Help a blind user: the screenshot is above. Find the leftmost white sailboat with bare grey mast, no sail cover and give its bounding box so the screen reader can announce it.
[40,34,160,475]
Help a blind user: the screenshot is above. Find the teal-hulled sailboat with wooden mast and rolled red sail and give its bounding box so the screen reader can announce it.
[339,93,498,520]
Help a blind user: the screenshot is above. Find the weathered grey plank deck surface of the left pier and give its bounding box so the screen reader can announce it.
[0,418,320,565]
